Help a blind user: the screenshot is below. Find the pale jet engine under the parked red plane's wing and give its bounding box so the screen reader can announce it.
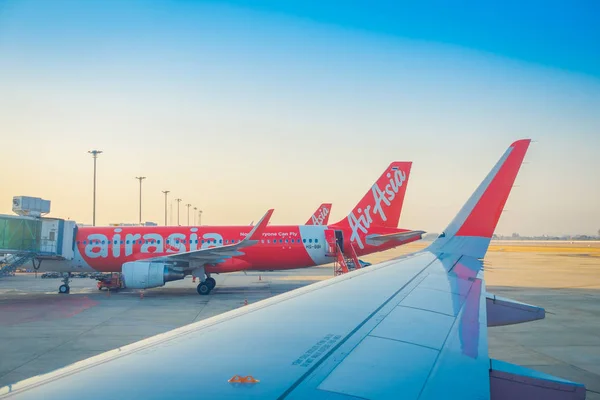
[121,261,185,289]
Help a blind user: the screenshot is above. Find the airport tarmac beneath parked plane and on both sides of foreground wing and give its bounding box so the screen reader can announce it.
[0,239,600,400]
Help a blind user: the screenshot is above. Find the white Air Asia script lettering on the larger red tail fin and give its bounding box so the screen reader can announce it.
[348,167,406,249]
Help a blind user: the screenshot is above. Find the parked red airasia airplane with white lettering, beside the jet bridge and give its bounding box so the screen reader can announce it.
[37,161,425,295]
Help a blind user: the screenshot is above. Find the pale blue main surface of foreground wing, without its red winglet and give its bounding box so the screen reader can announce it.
[0,253,489,399]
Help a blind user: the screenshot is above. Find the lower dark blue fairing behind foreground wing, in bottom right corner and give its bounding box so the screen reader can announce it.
[490,359,585,400]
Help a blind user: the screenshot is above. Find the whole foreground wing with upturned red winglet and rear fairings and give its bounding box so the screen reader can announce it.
[0,139,585,400]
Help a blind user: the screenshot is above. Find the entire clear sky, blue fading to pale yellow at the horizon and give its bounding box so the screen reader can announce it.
[0,0,600,234]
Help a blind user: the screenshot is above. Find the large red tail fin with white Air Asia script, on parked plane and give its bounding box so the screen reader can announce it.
[334,161,412,228]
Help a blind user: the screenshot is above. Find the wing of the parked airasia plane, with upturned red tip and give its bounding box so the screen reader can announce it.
[144,209,273,264]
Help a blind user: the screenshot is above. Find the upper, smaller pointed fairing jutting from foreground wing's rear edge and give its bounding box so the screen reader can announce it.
[486,293,546,326]
